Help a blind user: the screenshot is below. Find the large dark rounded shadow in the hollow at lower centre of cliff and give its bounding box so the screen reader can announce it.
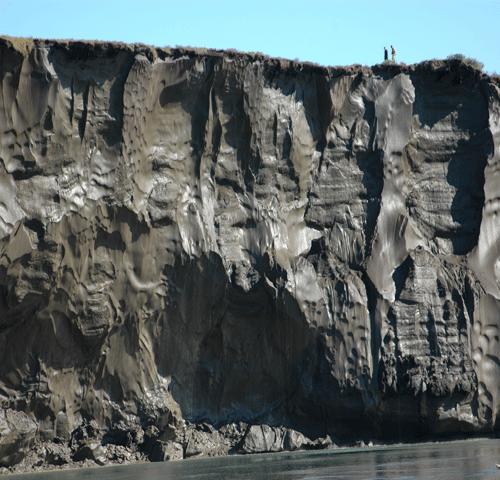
[155,254,320,425]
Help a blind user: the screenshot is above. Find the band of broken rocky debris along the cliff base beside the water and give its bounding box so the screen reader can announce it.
[0,423,337,472]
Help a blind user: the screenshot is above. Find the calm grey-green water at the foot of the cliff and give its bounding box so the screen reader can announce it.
[7,439,500,480]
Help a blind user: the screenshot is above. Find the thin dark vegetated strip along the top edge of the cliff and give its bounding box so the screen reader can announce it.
[0,35,500,85]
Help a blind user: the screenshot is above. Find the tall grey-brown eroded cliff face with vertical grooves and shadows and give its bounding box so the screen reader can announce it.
[0,39,500,465]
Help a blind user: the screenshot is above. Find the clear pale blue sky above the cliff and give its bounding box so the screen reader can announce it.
[0,0,500,73]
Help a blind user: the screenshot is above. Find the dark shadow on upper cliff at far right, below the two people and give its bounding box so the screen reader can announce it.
[412,70,494,255]
